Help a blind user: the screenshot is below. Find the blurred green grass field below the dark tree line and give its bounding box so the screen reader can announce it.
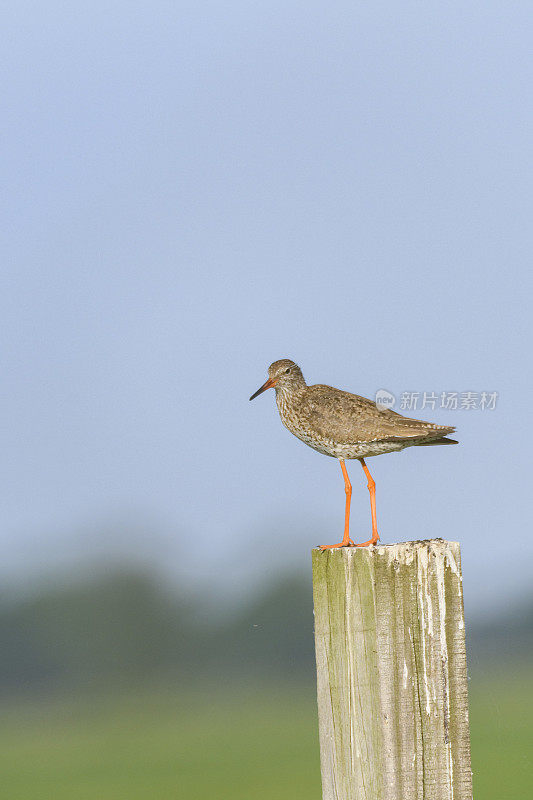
[0,675,533,800]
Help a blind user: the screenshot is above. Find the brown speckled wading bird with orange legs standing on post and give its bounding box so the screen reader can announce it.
[250,358,458,550]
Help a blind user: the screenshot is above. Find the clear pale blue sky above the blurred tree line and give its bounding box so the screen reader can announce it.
[0,2,533,613]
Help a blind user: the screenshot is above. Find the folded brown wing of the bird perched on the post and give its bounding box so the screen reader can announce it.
[305,384,454,444]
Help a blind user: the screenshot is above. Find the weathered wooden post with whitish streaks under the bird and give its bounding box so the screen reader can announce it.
[313,539,472,800]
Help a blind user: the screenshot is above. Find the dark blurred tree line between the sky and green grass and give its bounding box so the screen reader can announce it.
[0,571,533,693]
